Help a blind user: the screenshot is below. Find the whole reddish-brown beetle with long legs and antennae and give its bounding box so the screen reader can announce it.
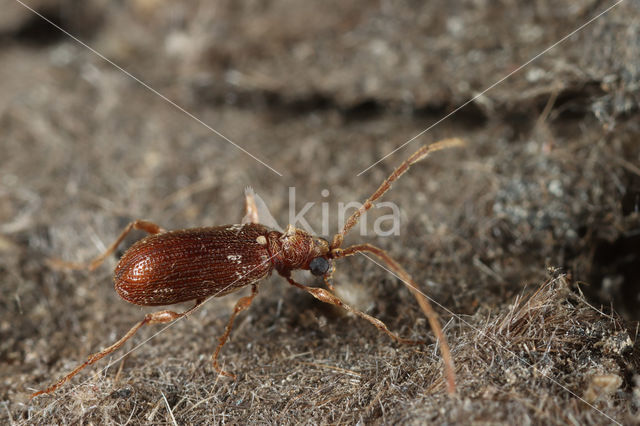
[31,138,464,398]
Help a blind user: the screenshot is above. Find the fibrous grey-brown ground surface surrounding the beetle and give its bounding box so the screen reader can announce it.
[0,0,640,424]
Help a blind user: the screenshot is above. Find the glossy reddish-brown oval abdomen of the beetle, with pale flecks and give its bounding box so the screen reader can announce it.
[114,224,273,306]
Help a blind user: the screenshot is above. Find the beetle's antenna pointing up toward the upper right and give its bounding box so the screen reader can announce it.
[331,138,466,250]
